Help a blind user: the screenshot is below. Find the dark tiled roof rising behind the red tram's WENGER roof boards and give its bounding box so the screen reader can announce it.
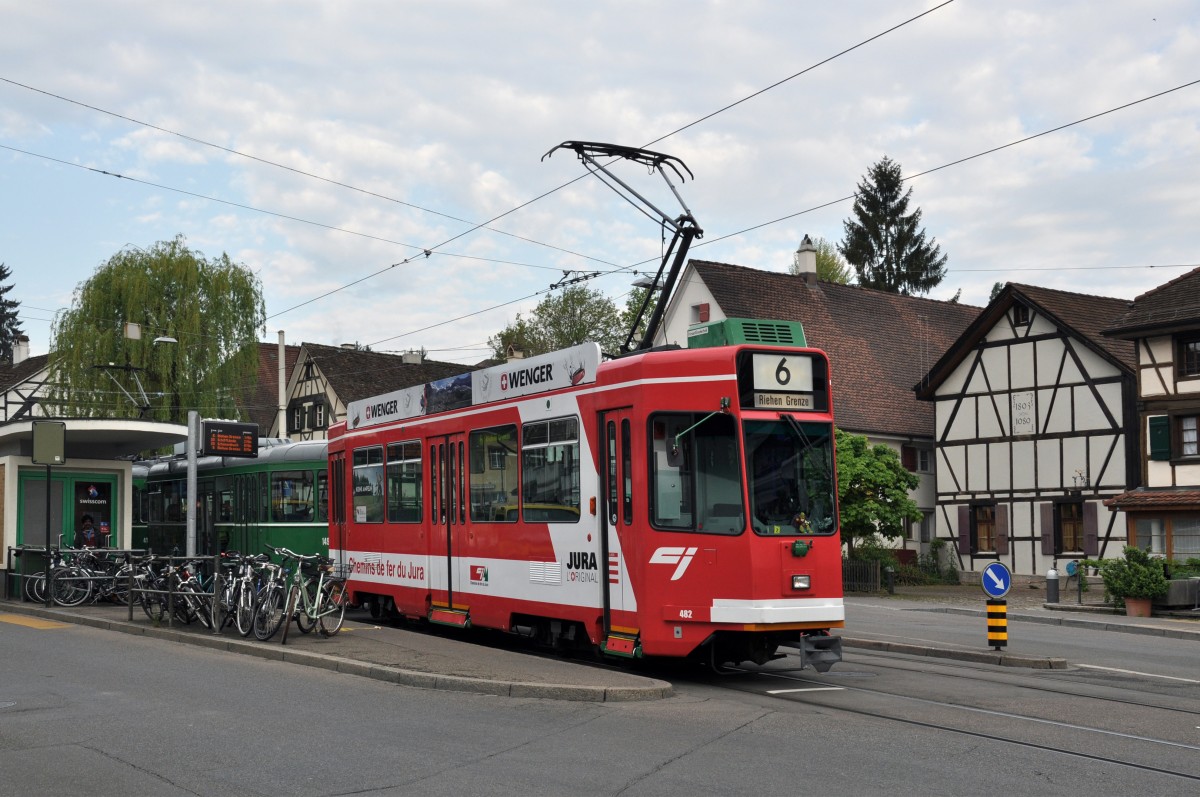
[304,343,478,403]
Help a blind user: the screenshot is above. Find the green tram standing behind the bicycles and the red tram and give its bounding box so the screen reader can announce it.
[133,438,329,556]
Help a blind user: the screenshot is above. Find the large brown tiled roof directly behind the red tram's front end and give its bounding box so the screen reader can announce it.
[691,260,979,437]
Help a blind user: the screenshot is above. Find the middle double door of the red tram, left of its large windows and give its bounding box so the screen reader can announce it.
[427,435,469,625]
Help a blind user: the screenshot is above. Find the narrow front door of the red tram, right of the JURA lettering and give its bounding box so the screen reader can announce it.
[600,407,638,635]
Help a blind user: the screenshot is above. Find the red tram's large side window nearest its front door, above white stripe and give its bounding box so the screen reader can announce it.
[521,418,580,523]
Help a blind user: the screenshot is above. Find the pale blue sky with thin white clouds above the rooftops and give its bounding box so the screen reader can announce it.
[0,0,1200,362]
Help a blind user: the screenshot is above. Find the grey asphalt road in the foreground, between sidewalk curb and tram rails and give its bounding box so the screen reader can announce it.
[0,607,1200,797]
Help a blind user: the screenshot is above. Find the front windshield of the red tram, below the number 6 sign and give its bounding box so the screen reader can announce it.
[744,415,838,535]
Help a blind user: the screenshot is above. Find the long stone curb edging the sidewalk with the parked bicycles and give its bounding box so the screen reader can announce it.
[0,601,674,702]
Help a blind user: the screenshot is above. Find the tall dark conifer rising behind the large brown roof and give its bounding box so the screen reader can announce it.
[838,157,947,296]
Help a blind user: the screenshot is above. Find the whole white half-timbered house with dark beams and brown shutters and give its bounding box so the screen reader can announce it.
[914,283,1138,575]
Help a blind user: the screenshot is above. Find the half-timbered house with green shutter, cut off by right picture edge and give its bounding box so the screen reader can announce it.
[1104,269,1200,561]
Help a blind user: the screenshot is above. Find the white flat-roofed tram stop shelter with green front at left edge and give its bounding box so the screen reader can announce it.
[0,418,187,583]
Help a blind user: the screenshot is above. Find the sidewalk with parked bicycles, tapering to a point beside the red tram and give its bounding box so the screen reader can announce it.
[0,599,672,702]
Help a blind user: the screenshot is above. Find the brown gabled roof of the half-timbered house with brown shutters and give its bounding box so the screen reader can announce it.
[917,282,1136,401]
